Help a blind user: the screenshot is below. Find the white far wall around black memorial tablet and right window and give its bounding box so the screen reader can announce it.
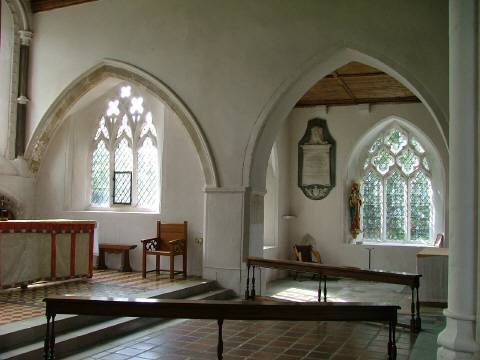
[287,103,448,272]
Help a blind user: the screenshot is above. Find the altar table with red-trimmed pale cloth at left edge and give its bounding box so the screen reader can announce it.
[0,220,96,288]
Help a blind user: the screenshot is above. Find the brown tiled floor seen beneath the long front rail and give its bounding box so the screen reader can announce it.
[69,320,442,360]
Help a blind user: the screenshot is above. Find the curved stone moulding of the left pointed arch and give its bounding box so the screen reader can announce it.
[25,59,220,187]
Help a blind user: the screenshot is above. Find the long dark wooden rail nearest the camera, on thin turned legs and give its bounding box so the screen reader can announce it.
[44,296,399,360]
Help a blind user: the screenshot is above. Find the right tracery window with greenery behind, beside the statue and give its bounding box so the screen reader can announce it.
[360,126,434,245]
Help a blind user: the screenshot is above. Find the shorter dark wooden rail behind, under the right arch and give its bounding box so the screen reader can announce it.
[245,256,422,331]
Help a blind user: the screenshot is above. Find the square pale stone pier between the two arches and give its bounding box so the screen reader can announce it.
[203,187,264,296]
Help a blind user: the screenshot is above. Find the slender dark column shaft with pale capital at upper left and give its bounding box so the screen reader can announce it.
[15,30,32,157]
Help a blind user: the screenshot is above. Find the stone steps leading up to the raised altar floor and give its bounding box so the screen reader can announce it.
[0,281,226,360]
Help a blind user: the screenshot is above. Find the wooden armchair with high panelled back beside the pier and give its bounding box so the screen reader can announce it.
[142,221,188,280]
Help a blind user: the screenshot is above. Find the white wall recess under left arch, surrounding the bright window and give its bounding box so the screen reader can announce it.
[35,84,205,275]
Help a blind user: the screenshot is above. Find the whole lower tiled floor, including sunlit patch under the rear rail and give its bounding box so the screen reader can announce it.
[68,279,445,360]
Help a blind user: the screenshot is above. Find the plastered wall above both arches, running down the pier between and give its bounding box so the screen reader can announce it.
[24,0,448,290]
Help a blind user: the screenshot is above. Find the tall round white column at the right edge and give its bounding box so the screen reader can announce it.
[437,0,479,359]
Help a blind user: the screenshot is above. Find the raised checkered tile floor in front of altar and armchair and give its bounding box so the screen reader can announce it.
[0,270,196,325]
